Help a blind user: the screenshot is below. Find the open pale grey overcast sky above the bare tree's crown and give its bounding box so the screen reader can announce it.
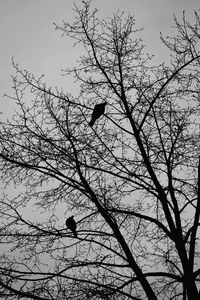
[0,0,200,110]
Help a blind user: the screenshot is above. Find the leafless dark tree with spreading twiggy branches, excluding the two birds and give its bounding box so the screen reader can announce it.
[0,2,200,300]
